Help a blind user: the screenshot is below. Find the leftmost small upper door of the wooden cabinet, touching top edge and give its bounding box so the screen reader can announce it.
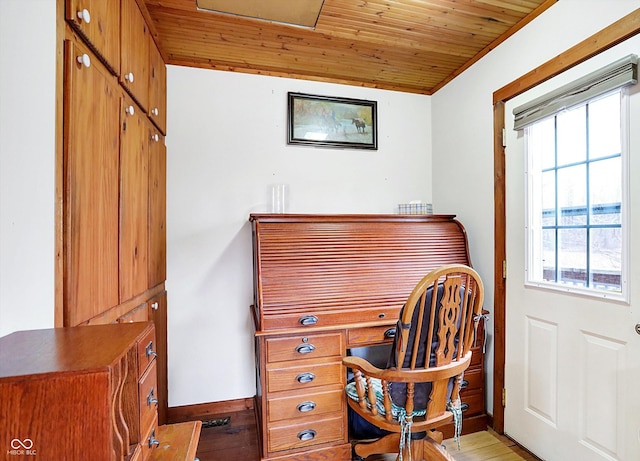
[65,0,120,73]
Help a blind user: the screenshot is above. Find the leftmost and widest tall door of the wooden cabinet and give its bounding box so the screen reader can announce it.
[63,41,121,326]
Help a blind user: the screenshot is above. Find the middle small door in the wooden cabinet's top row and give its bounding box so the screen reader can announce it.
[120,0,150,112]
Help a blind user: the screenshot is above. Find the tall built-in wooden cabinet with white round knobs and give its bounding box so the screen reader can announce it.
[55,0,168,430]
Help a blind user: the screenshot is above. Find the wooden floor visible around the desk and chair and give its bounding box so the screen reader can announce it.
[197,410,540,461]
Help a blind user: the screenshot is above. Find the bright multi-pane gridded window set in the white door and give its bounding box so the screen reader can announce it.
[525,89,628,297]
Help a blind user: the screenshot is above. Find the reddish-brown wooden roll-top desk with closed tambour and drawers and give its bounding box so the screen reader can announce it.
[250,214,487,461]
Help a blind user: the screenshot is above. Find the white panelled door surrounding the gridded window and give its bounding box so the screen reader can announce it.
[505,45,640,461]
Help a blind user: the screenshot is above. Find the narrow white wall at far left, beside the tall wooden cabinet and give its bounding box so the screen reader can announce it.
[0,0,56,336]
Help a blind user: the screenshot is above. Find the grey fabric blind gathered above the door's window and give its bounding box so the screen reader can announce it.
[513,54,638,130]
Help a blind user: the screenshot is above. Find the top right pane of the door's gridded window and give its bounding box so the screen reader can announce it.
[589,93,621,159]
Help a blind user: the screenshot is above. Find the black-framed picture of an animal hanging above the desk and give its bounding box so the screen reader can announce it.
[288,93,378,150]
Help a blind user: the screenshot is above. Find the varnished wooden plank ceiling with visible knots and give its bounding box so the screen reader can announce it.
[144,0,557,94]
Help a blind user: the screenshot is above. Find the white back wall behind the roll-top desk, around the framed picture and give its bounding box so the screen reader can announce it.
[167,66,431,406]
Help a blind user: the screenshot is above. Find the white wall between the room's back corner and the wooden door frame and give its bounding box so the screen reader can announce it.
[432,0,640,411]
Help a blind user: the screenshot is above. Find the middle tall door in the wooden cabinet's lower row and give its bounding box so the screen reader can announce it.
[120,97,149,302]
